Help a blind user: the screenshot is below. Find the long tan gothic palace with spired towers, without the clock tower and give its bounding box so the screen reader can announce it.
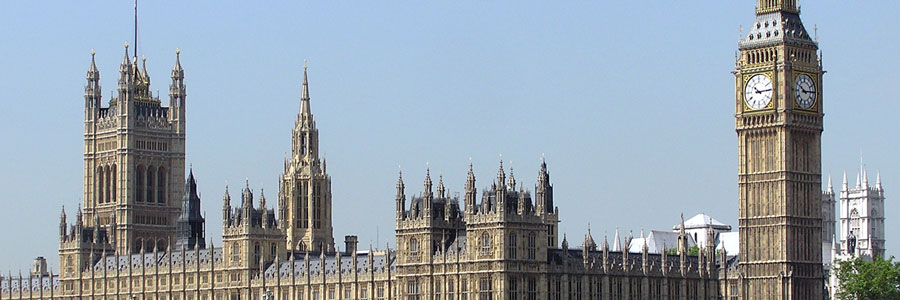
[0,42,717,300]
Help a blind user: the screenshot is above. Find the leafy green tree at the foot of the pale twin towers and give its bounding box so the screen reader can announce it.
[834,257,900,300]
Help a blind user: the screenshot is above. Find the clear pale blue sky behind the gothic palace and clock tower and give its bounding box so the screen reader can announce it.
[0,0,900,270]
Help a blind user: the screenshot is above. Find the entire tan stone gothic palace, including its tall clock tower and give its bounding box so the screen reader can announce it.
[0,0,884,300]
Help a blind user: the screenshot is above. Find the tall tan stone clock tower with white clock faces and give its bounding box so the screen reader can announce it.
[734,0,824,299]
